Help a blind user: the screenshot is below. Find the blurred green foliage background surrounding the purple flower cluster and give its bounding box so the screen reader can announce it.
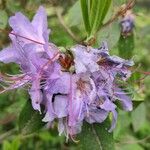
[0,0,150,150]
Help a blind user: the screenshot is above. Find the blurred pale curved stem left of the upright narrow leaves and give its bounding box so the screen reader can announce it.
[55,8,80,43]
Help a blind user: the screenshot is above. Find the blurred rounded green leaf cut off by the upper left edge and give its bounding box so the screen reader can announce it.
[0,10,8,29]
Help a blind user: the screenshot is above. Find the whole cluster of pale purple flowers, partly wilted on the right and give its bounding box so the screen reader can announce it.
[0,7,133,137]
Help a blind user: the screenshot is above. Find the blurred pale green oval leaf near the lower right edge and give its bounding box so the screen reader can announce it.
[131,103,146,132]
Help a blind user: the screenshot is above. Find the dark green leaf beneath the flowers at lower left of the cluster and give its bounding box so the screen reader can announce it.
[18,100,45,135]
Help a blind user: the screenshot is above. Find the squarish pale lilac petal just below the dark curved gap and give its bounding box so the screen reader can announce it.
[54,95,68,118]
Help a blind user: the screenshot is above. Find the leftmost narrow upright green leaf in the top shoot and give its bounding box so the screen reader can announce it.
[80,0,91,34]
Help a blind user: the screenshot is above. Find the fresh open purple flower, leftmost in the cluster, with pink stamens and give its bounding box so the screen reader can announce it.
[0,7,61,111]
